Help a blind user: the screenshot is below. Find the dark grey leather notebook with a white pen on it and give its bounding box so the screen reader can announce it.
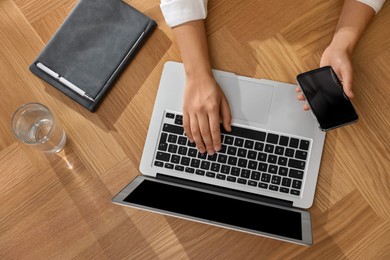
[30,0,157,111]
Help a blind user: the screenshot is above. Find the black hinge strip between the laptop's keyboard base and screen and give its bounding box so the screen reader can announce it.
[156,173,293,207]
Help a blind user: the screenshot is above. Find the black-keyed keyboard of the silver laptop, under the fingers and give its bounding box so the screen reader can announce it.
[154,112,310,196]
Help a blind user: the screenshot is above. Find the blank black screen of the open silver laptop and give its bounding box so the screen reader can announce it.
[124,180,302,240]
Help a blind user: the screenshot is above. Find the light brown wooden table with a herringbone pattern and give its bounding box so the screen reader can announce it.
[0,0,390,259]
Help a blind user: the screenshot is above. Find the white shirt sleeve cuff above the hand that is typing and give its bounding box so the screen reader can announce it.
[160,0,207,27]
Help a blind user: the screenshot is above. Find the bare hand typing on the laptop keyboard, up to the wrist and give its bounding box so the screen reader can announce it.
[183,73,231,155]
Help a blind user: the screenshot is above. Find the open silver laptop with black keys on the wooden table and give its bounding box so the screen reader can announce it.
[112,61,325,245]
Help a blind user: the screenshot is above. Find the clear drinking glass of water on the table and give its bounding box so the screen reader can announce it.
[11,103,66,153]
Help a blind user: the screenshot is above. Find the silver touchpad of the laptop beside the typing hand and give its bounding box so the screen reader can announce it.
[217,76,274,124]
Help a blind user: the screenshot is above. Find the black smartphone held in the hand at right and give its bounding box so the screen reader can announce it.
[297,66,359,131]
